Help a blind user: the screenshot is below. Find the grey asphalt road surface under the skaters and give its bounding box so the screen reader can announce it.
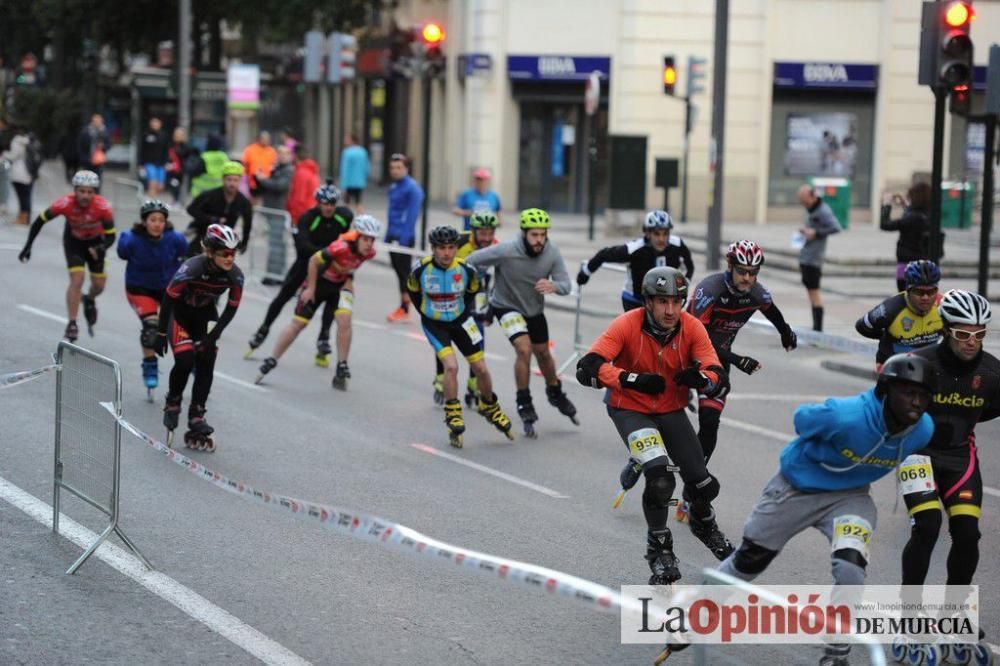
[0,214,1000,664]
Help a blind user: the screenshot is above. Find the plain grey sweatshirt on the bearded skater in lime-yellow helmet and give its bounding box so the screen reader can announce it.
[466,237,572,317]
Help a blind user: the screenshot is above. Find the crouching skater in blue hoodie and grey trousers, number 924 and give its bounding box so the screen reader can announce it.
[661,354,935,666]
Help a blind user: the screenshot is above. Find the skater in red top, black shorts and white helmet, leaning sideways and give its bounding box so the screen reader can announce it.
[257,215,382,390]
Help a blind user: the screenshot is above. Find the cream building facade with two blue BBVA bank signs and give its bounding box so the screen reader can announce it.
[380,0,1000,224]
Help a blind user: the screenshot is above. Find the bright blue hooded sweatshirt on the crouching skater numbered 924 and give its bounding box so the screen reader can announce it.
[781,388,934,492]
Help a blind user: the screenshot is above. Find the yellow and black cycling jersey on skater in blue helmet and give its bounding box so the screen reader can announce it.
[854,292,944,364]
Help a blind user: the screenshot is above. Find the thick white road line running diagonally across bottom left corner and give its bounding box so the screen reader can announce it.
[0,477,309,666]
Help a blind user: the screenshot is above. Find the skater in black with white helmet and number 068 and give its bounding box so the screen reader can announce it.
[900,289,1000,663]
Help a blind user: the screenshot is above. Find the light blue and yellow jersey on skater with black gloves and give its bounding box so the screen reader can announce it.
[406,257,480,322]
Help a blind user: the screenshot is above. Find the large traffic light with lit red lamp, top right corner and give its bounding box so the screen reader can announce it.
[918,0,976,90]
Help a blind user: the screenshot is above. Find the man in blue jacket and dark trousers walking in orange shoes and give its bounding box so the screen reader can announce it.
[385,153,424,322]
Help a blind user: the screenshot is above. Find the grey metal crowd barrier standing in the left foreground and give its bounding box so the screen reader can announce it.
[52,341,153,574]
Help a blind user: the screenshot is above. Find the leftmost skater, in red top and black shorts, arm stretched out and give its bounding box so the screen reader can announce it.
[17,170,115,342]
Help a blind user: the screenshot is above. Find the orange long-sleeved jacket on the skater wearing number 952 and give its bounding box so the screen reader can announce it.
[589,308,722,414]
